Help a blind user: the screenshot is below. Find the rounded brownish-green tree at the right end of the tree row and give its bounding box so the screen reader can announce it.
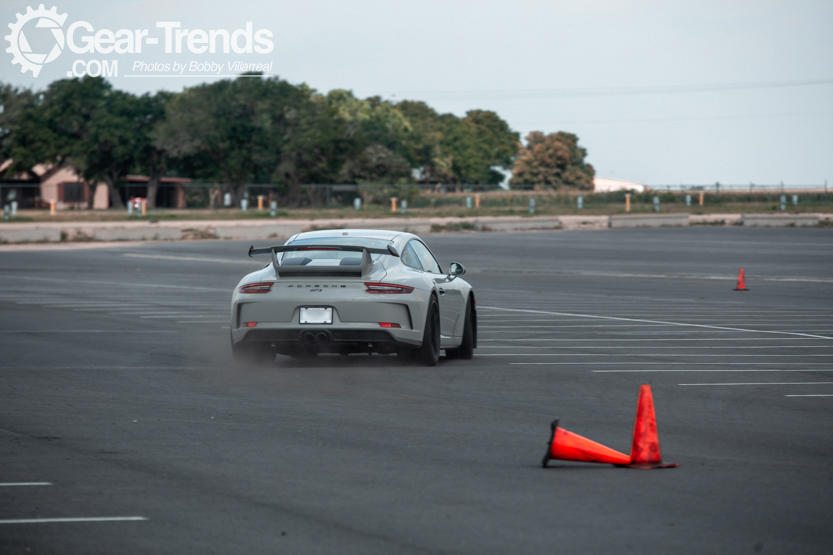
[510,131,595,189]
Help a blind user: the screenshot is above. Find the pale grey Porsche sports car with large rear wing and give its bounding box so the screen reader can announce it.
[231,229,477,366]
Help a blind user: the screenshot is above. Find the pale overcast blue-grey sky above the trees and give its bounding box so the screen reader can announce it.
[0,0,833,186]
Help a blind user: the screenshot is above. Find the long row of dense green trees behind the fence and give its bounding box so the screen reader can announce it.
[0,74,594,207]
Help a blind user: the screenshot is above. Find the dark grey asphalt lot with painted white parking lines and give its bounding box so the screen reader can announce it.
[0,227,833,554]
